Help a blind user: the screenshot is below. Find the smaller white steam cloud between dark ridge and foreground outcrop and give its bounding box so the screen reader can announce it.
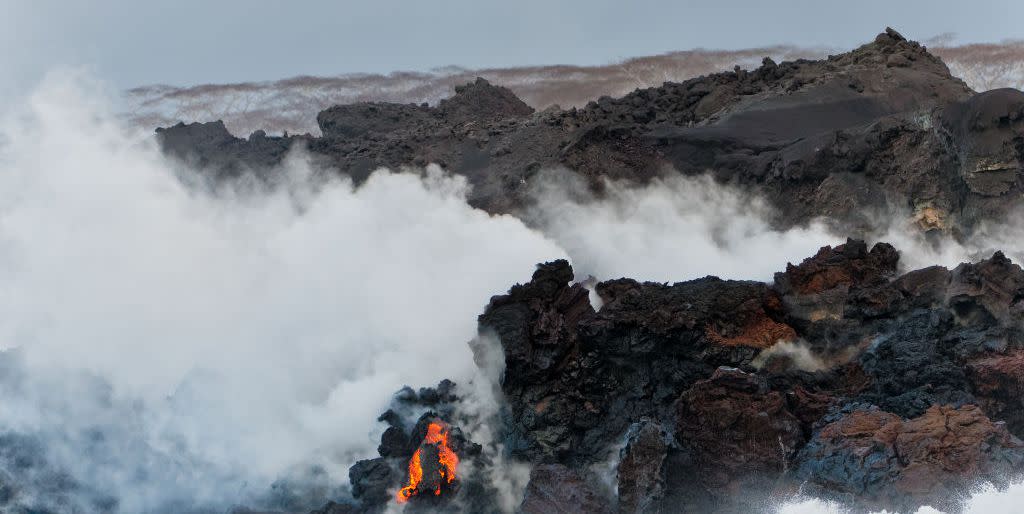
[530,173,845,282]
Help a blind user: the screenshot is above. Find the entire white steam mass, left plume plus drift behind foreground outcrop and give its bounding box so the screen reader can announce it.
[0,73,1009,513]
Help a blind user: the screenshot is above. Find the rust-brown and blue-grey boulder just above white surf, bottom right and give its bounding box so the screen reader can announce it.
[796,405,1024,510]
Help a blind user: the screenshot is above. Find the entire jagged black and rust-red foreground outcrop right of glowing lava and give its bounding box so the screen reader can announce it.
[462,240,1024,512]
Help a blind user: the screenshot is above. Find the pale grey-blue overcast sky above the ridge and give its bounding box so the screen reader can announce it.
[0,0,1024,94]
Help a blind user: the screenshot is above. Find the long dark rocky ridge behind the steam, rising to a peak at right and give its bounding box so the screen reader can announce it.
[158,30,1024,234]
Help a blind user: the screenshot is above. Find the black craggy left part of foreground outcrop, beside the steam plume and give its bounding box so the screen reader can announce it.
[479,261,795,463]
